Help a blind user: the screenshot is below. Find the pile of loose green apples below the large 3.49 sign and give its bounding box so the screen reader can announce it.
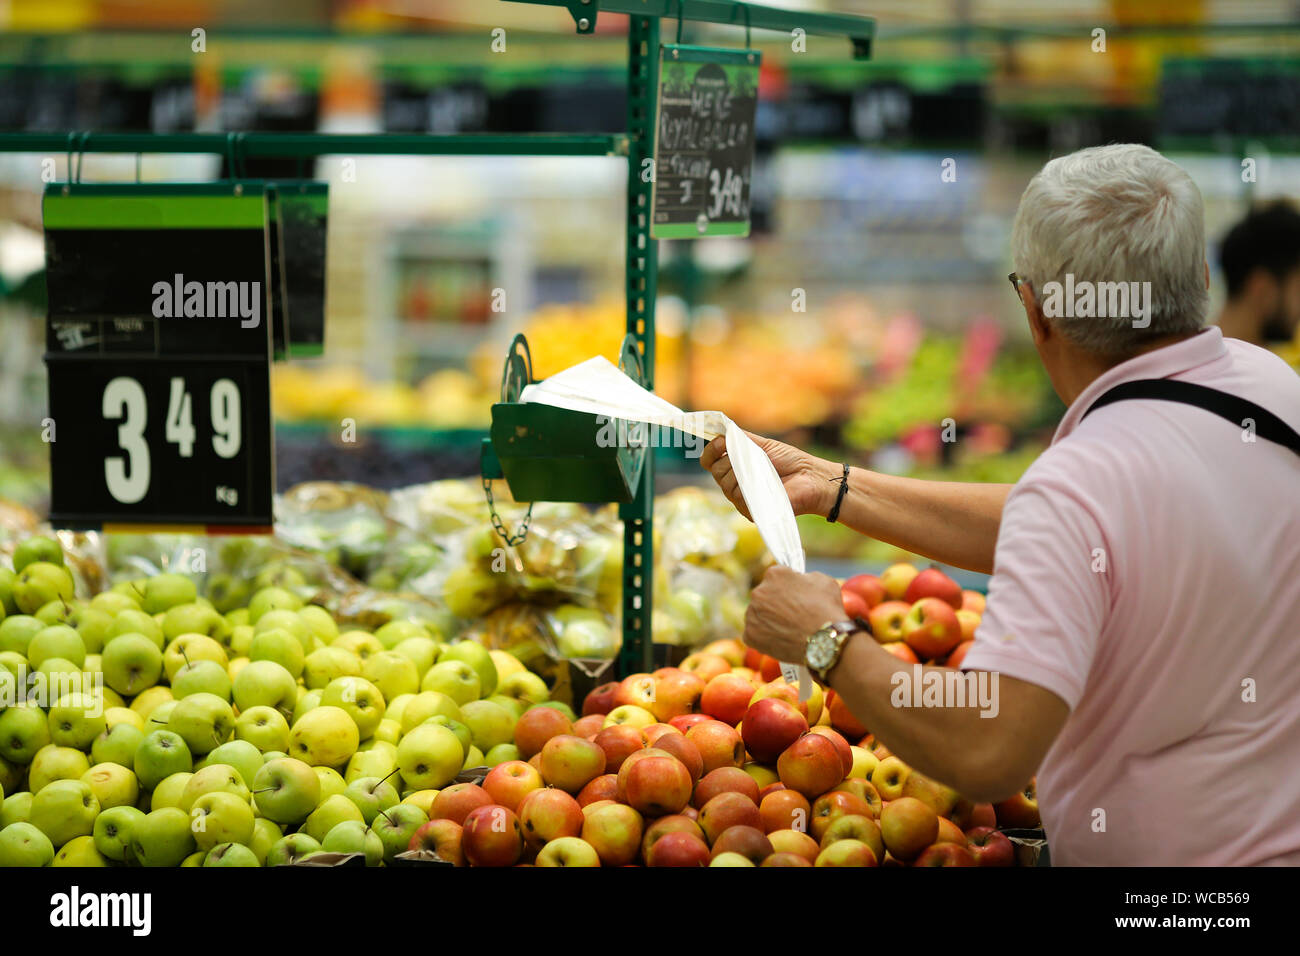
[0,537,575,866]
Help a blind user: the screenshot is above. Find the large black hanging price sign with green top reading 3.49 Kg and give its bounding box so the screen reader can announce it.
[43,183,274,533]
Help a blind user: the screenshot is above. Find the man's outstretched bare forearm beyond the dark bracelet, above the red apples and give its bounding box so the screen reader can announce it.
[822,468,1011,574]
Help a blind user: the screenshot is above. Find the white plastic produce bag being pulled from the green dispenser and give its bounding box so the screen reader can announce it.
[520,355,813,700]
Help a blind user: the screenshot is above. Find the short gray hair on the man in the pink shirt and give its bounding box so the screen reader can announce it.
[1011,143,1209,356]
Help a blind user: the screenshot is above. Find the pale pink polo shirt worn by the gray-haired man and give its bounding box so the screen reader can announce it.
[963,328,1300,866]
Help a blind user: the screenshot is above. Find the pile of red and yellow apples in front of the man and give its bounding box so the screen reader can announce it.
[411,566,1039,866]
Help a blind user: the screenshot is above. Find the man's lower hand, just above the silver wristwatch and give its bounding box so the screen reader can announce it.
[744,564,846,663]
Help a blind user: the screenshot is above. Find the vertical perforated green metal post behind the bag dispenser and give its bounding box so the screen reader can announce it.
[619,9,659,676]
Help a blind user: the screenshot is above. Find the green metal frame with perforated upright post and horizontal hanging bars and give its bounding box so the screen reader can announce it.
[0,0,875,675]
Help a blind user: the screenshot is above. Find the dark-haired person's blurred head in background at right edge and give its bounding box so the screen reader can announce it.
[1218,202,1300,364]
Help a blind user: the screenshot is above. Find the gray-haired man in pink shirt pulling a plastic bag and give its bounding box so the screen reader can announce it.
[702,146,1300,865]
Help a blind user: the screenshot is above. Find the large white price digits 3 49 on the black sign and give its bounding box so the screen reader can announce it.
[103,377,243,505]
